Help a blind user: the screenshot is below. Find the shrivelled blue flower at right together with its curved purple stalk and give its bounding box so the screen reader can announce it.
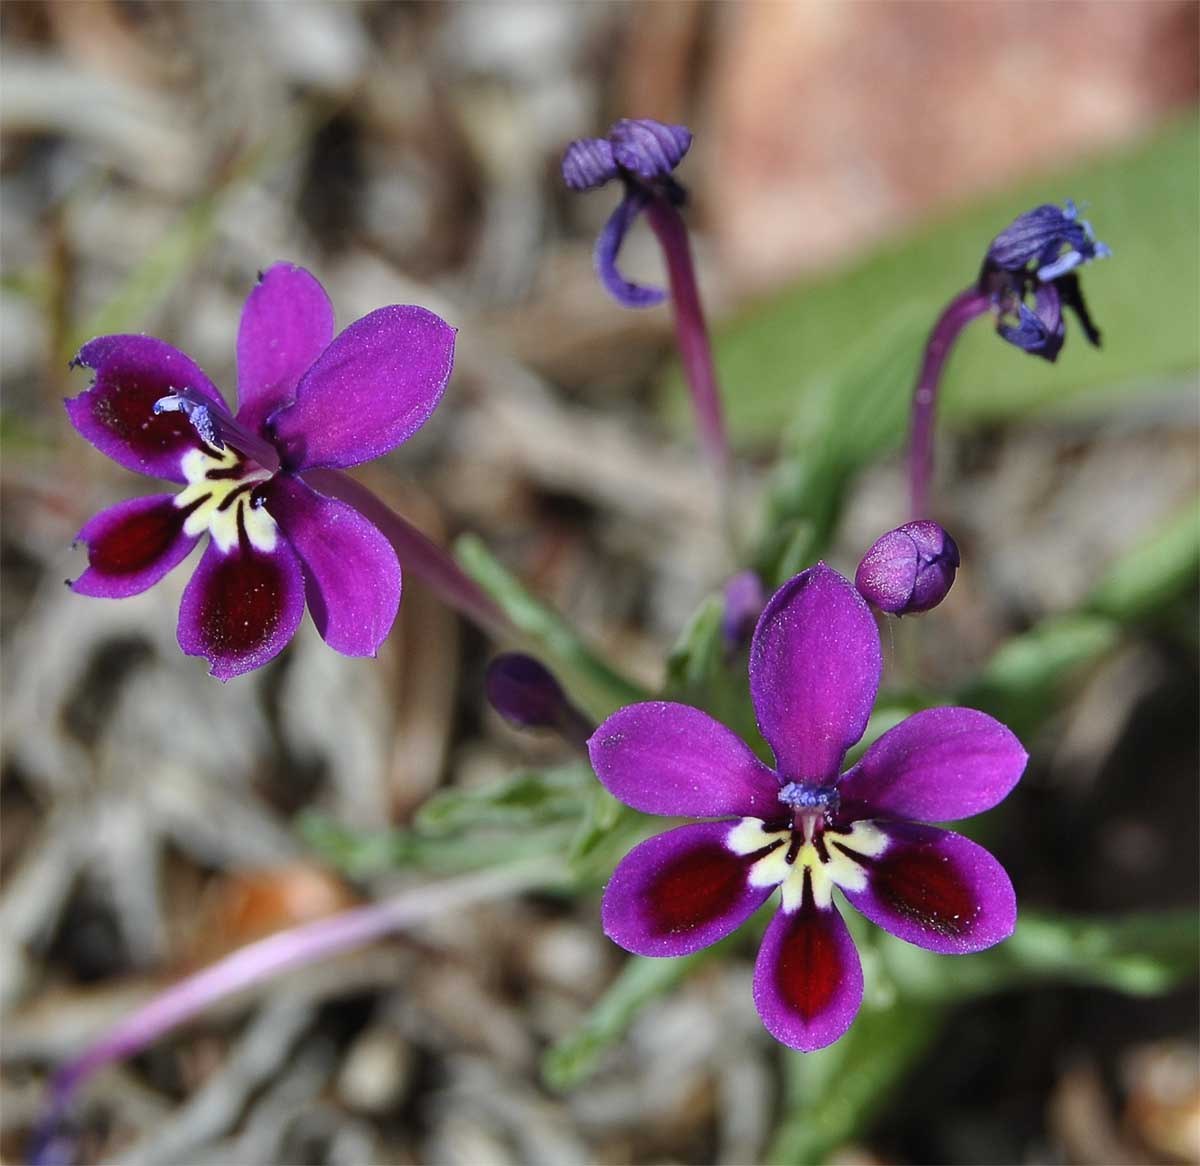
[908,199,1110,518]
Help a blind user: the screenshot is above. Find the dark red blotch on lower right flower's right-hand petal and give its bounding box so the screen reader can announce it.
[849,843,979,938]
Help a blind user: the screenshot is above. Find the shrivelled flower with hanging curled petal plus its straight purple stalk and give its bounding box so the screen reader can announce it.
[563,118,731,479]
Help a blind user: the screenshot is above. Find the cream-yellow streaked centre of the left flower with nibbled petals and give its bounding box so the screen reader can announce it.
[175,445,278,554]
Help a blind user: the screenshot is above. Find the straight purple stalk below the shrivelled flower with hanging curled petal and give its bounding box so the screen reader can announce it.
[646,198,732,482]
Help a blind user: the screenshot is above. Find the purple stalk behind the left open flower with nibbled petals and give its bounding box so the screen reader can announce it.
[300,469,517,639]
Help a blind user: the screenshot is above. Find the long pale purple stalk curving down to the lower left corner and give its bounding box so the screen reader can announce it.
[34,858,562,1158]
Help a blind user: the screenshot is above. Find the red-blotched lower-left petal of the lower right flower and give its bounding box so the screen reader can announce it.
[602,822,774,956]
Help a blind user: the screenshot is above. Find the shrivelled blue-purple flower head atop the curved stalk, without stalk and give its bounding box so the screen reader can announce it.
[979,199,1110,361]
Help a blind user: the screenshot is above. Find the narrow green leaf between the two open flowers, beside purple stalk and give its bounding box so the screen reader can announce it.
[455,535,648,719]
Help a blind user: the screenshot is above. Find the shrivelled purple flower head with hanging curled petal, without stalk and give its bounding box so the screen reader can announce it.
[563,118,691,307]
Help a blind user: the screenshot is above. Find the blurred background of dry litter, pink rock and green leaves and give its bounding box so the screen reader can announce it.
[0,0,1200,1166]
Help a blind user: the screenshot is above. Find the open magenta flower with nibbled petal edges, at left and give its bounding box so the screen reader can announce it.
[66,264,455,680]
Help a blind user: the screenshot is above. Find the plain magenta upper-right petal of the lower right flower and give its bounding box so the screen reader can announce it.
[840,709,1028,822]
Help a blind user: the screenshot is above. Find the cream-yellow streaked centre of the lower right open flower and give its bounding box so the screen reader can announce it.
[725,810,888,912]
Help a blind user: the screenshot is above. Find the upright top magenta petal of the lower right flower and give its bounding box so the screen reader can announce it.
[750,563,883,782]
